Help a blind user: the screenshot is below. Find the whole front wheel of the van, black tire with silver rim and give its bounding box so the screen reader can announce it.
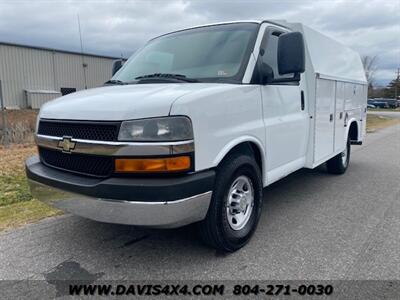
[198,153,263,252]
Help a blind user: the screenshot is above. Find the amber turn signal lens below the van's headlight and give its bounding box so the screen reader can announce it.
[115,156,190,173]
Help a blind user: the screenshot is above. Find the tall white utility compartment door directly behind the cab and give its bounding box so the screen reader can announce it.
[314,78,336,163]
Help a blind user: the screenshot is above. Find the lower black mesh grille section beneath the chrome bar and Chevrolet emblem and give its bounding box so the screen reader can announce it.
[39,147,114,177]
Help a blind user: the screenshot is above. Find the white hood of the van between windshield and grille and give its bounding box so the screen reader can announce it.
[40,83,219,121]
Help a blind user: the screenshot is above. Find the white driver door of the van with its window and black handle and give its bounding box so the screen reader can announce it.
[259,27,309,183]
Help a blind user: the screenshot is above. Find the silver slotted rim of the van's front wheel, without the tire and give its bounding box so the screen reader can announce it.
[226,176,254,230]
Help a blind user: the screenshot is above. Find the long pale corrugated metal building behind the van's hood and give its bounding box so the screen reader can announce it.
[0,42,122,108]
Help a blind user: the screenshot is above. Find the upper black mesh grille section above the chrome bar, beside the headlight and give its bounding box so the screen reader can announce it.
[38,120,120,141]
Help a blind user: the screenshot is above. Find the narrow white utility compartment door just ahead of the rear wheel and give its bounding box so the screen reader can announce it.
[335,81,346,152]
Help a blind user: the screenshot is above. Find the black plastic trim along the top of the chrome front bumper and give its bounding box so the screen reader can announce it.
[25,156,215,202]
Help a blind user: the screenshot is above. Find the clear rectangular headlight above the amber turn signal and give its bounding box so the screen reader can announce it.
[118,117,193,142]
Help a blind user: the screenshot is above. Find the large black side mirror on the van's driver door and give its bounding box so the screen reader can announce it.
[278,32,305,75]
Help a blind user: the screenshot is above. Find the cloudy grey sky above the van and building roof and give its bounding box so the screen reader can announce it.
[0,0,400,86]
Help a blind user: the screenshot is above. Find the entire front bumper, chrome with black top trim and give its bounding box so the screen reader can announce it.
[26,157,215,228]
